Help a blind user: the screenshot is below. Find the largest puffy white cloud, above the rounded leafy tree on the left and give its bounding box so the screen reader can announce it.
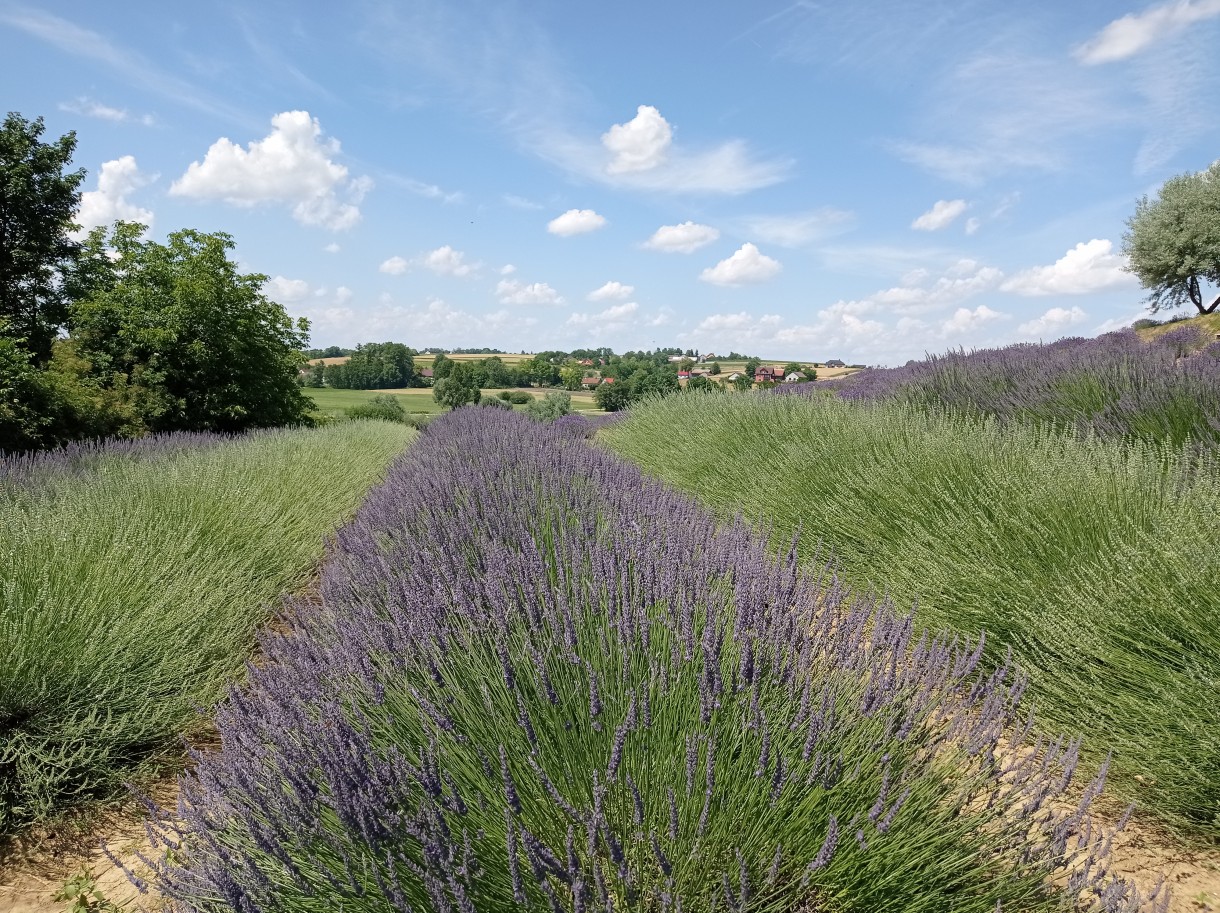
[170,111,372,231]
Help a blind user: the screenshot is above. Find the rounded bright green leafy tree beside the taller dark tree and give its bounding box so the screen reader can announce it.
[68,222,310,432]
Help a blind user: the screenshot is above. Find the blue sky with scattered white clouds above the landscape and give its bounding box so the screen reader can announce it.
[0,0,1220,365]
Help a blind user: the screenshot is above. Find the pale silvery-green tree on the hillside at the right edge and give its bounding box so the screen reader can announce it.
[1122,161,1220,314]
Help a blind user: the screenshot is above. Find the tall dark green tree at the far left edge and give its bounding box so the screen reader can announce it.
[0,112,84,365]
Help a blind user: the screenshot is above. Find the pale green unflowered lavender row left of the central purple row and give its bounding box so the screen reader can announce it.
[0,422,415,835]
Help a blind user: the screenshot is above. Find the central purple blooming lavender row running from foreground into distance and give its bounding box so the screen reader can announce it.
[147,409,1156,913]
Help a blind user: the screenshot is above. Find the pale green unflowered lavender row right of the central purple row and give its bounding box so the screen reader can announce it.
[600,395,1220,840]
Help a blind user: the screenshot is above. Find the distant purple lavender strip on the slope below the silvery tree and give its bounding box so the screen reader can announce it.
[805,326,1220,447]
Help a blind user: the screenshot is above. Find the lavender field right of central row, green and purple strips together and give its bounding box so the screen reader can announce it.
[600,328,1220,841]
